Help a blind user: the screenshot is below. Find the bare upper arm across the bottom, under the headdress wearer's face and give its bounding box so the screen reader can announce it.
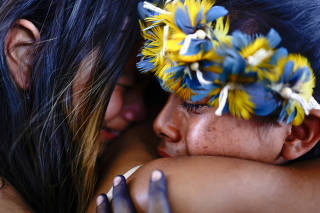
[129,157,320,213]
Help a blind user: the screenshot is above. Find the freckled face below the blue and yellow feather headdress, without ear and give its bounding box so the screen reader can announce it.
[154,95,290,163]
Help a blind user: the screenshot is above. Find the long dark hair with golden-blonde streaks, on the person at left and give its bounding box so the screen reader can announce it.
[0,0,138,213]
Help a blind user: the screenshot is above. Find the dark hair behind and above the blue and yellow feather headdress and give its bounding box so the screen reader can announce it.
[216,0,320,160]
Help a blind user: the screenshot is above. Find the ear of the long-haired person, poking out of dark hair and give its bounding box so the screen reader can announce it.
[5,19,40,90]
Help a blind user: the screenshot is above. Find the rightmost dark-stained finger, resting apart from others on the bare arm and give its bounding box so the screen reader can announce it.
[148,170,170,213]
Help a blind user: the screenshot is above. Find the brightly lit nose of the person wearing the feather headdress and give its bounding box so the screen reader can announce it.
[153,95,181,142]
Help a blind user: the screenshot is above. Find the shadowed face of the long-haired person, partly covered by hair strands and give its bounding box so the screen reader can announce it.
[73,53,146,141]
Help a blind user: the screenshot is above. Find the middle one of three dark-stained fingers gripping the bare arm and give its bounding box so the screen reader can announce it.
[113,175,136,213]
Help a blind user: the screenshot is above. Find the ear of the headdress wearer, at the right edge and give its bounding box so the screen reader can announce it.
[281,110,320,160]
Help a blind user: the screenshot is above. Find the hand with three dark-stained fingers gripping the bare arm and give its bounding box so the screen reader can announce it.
[96,170,170,213]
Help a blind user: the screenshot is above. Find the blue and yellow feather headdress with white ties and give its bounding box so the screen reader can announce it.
[138,0,320,125]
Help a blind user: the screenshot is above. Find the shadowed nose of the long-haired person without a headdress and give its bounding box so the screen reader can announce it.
[121,89,147,121]
